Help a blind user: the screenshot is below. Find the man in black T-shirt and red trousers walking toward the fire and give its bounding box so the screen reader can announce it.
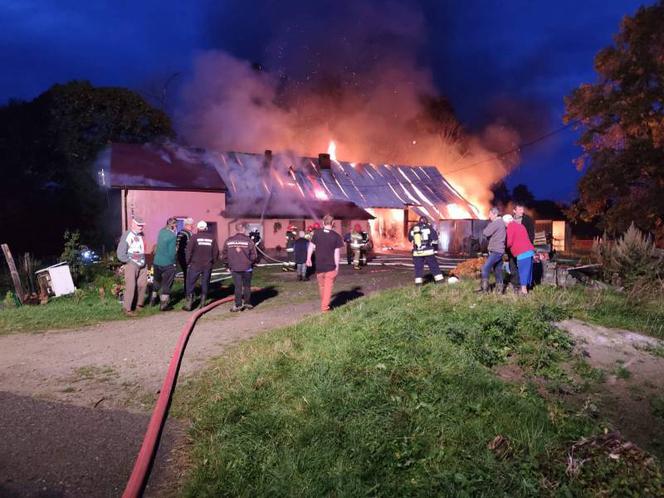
[306,214,344,313]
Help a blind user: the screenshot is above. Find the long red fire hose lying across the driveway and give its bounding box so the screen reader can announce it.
[122,289,253,498]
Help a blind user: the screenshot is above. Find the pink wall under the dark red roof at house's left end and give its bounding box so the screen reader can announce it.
[122,190,228,252]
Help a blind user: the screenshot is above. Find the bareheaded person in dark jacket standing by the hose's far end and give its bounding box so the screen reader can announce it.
[221,223,258,312]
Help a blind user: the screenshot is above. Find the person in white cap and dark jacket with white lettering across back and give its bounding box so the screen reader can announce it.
[183,221,219,311]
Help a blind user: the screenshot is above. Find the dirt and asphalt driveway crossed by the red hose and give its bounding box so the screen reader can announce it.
[0,269,411,497]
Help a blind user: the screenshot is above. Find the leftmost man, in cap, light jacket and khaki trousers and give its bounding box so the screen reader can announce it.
[116,216,148,316]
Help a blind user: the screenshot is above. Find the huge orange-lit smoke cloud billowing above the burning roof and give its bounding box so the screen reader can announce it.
[176,0,520,211]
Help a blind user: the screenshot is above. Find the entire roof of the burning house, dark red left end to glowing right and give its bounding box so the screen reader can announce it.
[111,143,478,219]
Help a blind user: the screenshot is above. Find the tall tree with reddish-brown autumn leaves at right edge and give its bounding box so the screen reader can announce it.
[564,0,664,242]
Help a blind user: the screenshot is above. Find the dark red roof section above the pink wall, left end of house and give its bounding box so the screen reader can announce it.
[110,144,227,192]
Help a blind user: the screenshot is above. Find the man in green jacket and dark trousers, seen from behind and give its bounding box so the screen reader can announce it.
[150,218,177,311]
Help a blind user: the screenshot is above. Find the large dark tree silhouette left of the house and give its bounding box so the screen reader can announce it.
[0,81,173,255]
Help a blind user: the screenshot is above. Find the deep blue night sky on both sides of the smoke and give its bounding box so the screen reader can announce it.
[0,0,644,201]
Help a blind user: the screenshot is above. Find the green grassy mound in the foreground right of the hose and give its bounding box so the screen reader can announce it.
[174,285,664,496]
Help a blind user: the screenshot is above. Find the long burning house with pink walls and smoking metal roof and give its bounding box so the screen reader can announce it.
[107,143,479,251]
